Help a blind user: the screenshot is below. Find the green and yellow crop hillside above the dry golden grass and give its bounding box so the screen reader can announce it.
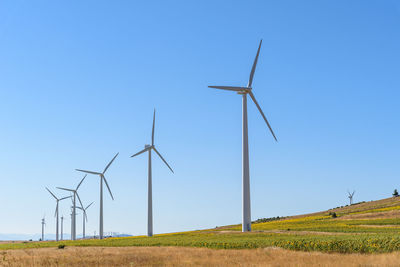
[0,197,400,253]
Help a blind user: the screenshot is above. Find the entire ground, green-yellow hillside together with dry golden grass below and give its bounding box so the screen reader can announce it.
[0,197,400,266]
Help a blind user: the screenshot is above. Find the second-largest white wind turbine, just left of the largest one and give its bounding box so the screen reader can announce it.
[131,109,174,236]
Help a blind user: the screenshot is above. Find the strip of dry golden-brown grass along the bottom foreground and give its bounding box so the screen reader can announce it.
[0,247,400,266]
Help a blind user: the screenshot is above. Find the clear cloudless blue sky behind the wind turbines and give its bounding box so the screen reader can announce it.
[0,0,400,239]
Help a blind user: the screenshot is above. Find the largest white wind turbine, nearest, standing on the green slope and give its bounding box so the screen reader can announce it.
[208,40,278,232]
